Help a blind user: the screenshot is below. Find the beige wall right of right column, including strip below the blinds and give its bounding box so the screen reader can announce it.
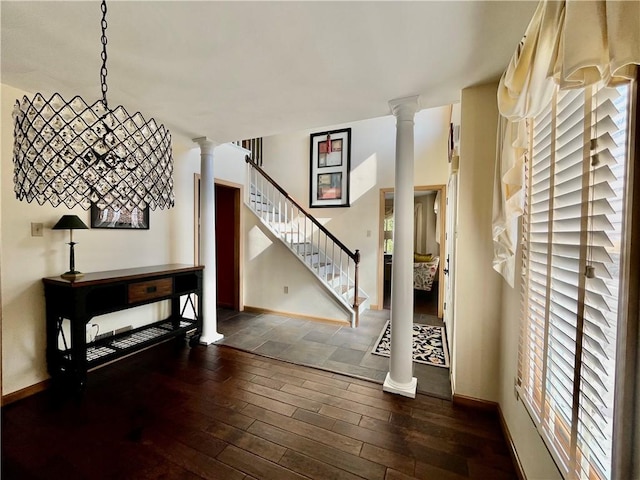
[452,84,561,480]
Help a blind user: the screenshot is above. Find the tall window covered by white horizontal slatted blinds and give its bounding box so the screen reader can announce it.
[518,80,629,480]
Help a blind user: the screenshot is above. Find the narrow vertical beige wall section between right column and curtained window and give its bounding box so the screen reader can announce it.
[452,84,500,401]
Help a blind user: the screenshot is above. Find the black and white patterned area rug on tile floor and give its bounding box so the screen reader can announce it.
[371,321,449,368]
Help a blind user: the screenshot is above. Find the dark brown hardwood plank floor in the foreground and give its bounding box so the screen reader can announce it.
[2,341,517,480]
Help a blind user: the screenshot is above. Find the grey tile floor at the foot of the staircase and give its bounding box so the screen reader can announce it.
[218,309,451,400]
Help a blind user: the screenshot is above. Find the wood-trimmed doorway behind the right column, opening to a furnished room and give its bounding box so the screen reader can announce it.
[378,185,446,319]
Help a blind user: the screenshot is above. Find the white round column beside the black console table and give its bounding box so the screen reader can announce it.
[193,137,223,345]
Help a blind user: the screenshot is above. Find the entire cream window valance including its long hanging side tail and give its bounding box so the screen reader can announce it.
[492,0,640,285]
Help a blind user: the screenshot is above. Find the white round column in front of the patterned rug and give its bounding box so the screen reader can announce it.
[382,96,418,398]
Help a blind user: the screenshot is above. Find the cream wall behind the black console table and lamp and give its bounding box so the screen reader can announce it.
[0,85,244,395]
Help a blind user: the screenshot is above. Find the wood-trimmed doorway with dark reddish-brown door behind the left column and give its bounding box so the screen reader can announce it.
[194,174,242,310]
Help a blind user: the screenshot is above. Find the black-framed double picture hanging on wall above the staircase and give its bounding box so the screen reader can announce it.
[309,128,351,208]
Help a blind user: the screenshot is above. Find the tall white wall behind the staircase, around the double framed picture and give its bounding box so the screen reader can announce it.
[258,107,449,318]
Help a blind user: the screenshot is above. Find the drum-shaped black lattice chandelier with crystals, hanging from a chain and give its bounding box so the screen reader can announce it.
[13,0,174,210]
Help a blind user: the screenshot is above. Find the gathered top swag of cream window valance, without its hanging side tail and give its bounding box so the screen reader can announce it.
[498,0,640,121]
